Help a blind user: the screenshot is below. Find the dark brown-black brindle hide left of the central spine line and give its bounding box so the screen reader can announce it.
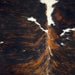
[0,0,49,75]
